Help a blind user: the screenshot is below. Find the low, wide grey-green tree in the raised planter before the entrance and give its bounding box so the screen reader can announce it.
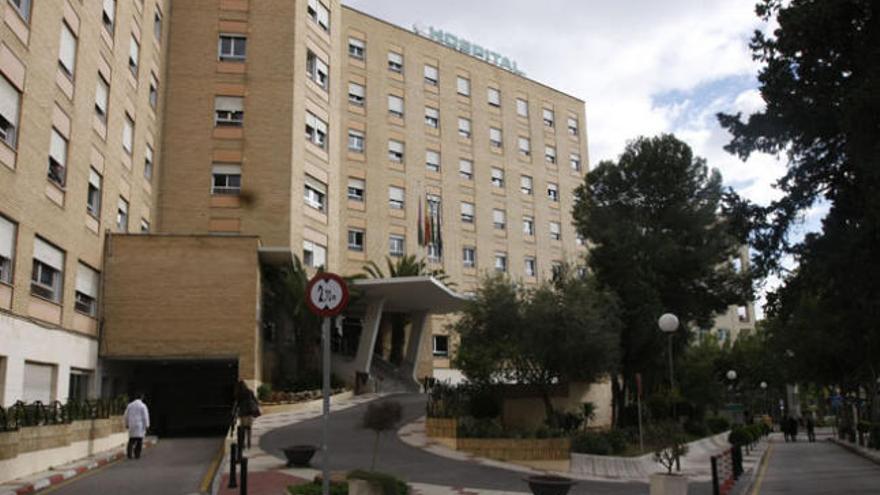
[453,266,620,424]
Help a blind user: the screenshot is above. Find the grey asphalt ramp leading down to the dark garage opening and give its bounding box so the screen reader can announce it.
[44,437,222,495]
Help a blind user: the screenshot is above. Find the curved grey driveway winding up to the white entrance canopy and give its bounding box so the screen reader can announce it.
[260,395,711,495]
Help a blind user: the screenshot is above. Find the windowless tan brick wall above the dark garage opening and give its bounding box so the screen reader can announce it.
[101,235,261,383]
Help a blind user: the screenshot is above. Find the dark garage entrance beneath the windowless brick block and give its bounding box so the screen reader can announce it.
[107,359,238,436]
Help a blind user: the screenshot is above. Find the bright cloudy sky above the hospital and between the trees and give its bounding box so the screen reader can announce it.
[343,0,824,316]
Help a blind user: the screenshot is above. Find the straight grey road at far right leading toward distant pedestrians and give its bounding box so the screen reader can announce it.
[753,440,880,495]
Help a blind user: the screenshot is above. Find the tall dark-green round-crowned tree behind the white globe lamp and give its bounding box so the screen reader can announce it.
[573,135,752,426]
